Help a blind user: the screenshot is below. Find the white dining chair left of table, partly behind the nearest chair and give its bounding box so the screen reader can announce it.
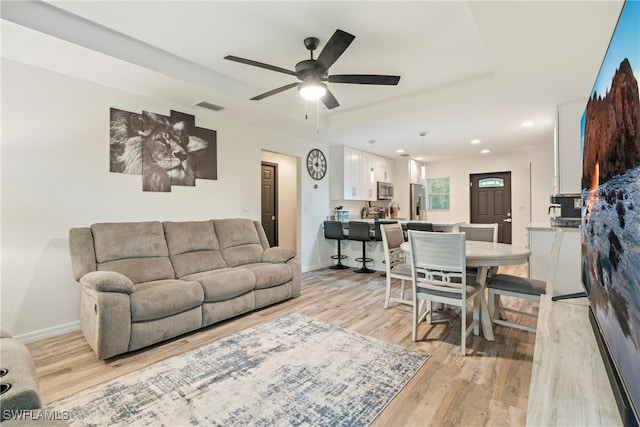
[380,223,413,309]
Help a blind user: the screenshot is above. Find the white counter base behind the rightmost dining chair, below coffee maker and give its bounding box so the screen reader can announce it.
[527,226,584,295]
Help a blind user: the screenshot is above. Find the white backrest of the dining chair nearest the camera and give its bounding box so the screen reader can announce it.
[409,230,467,301]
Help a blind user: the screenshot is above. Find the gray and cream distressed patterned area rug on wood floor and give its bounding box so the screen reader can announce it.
[49,313,429,426]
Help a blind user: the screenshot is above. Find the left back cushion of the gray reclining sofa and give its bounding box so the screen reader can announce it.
[91,221,175,283]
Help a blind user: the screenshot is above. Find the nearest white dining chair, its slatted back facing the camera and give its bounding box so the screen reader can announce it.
[409,231,483,356]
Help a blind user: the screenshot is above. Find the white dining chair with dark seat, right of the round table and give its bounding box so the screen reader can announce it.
[487,228,564,333]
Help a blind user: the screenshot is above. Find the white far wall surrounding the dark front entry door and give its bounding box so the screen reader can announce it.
[426,145,553,246]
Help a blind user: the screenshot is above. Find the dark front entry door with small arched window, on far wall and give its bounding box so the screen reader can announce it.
[469,172,511,243]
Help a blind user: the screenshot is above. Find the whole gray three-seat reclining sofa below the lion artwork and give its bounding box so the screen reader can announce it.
[69,218,301,359]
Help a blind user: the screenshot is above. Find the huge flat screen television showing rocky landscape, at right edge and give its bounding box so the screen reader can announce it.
[581,0,640,425]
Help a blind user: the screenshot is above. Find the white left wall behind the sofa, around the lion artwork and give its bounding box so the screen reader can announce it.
[1,59,332,341]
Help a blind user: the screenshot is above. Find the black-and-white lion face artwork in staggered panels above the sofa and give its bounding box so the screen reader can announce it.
[110,108,217,192]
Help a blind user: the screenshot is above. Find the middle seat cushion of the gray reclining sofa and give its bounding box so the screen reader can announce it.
[184,268,256,302]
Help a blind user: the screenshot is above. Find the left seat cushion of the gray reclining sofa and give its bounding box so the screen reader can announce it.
[129,279,204,322]
